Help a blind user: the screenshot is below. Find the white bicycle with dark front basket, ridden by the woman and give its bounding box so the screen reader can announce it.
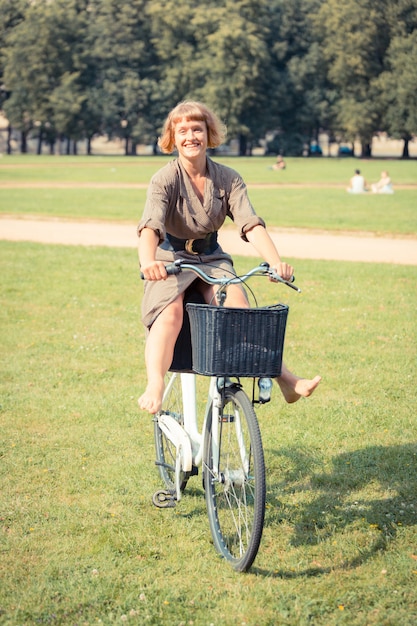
[145,260,300,572]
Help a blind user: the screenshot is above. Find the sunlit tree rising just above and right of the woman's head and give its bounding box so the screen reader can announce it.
[195,0,273,155]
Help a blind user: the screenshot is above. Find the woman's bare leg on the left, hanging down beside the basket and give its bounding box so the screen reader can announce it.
[138,295,183,413]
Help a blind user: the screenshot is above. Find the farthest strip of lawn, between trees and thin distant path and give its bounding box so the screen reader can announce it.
[0,155,417,187]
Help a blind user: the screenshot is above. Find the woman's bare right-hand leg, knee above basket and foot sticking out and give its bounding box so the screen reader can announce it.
[202,285,321,404]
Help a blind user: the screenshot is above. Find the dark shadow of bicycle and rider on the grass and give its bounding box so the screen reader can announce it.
[252,444,417,578]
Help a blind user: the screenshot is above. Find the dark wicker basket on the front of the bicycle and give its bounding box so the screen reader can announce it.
[186,303,288,378]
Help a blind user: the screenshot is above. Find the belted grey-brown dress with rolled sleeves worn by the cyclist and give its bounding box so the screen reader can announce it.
[137,158,265,328]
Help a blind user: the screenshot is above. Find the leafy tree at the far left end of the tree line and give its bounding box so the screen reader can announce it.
[4,0,91,151]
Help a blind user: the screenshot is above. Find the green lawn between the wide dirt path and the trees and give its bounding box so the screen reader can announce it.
[0,156,417,236]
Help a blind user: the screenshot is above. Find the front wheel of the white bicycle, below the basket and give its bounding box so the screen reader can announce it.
[203,385,266,572]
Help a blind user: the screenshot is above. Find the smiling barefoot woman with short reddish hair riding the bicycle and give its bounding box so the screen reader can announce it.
[138,102,321,413]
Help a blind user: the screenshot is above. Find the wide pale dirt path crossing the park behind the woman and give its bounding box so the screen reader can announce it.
[0,216,417,265]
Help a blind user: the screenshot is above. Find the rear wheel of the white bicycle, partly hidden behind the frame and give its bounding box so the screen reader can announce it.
[154,374,190,492]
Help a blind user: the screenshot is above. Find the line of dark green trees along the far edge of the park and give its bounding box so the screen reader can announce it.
[0,0,417,157]
